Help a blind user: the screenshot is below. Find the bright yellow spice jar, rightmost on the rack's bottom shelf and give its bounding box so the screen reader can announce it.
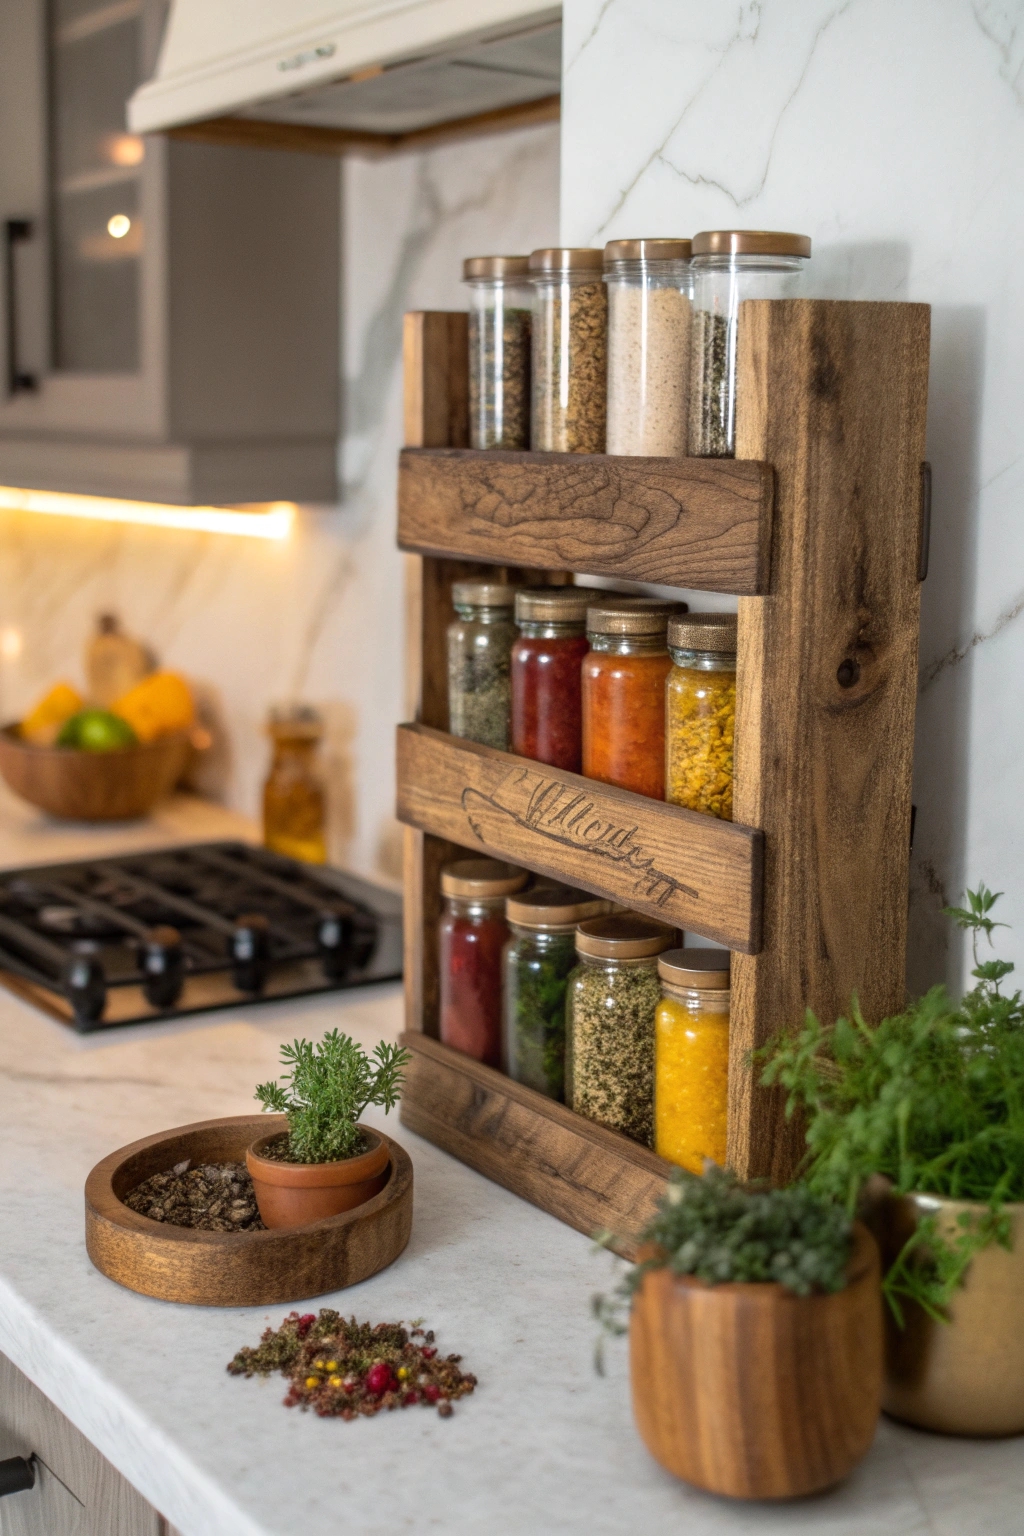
[654,949,729,1174]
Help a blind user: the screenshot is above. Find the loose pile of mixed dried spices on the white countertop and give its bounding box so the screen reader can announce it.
[227,1307,476,1419]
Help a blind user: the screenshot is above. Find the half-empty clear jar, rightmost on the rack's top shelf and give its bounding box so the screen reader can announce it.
[689,229,811,459]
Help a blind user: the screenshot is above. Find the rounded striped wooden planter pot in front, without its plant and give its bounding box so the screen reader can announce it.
[629,1223,883,1499]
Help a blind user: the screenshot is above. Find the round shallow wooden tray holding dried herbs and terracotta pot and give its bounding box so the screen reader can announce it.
[86,1115,413,1307]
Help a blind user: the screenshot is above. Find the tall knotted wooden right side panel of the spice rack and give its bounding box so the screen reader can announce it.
[729,300,929,1180]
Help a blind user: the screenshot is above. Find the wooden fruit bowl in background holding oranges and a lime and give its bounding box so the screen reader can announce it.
[0,725,190,822]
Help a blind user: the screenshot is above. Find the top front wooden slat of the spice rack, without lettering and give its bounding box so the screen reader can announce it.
[398,448,772,593]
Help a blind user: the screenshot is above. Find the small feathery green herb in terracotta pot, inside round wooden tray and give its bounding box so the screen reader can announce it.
[246,1029,408,1227]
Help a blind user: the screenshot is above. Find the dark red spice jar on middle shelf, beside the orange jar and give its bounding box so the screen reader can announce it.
[511,587,594,773]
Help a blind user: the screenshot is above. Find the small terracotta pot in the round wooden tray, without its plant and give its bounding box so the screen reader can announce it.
[246,1126,390,1227]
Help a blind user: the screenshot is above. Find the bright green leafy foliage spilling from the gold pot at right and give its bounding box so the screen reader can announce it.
[761,885,1024,1324]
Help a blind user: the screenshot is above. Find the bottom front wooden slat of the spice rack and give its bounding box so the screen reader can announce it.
[401,1032,671,1258]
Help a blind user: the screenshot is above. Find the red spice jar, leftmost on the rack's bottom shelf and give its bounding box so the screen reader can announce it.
[439,859,530,1066]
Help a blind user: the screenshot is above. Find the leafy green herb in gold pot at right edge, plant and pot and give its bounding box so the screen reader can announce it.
[763,885,1024,1435]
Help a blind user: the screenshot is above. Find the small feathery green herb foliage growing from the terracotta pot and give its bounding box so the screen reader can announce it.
[256,1029,408,1163]
